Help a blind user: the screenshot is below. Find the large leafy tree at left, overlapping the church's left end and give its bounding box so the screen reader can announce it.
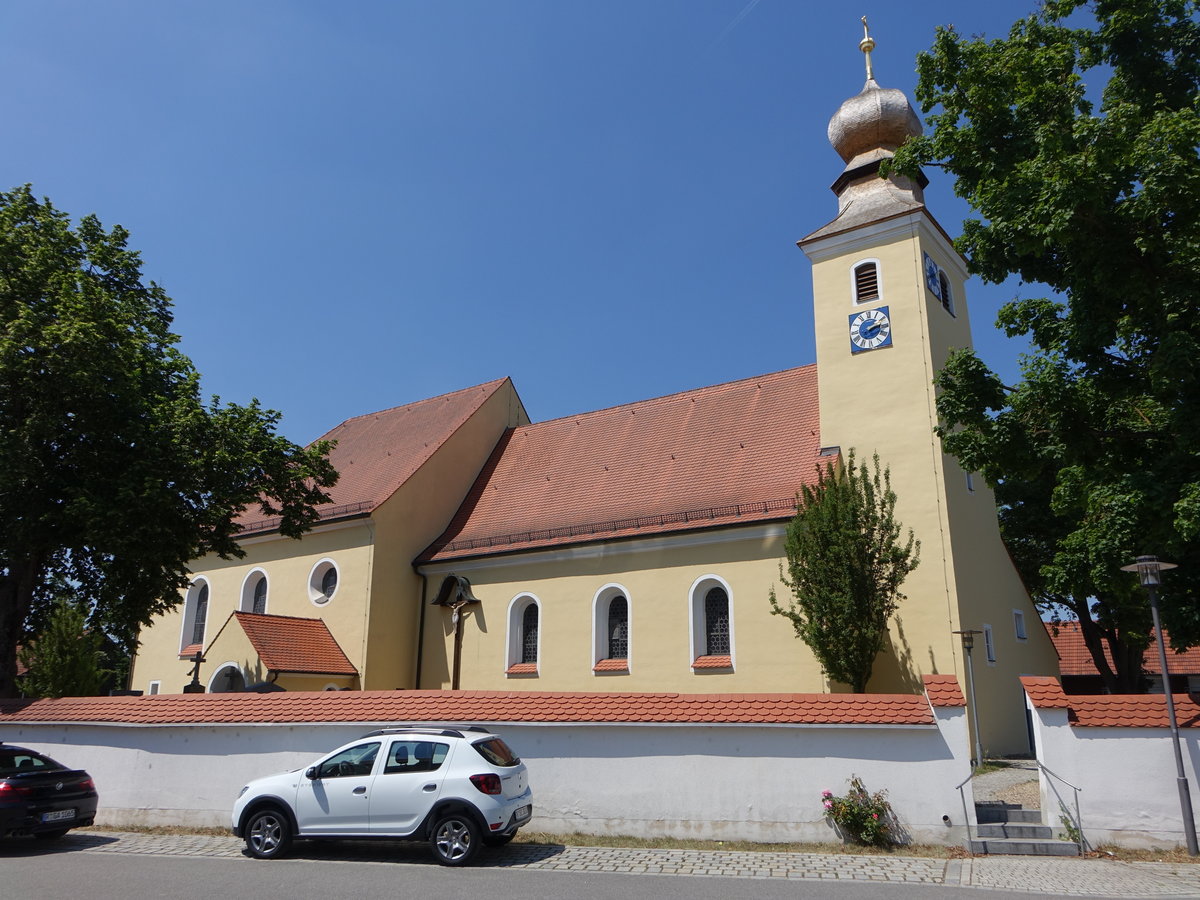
[0,186,337,697]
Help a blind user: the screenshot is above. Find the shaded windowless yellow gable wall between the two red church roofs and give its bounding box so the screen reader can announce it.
[361,380,529,690]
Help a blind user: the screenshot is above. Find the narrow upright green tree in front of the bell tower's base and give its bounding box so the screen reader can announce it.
[769,450,920,694]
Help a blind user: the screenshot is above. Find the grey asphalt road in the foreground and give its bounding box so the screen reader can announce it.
[0,852,1060,900]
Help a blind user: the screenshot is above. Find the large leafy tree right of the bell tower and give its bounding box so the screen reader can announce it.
[895,0,1200,691]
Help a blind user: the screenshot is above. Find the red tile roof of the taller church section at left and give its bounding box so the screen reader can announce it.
[239,378,508,533]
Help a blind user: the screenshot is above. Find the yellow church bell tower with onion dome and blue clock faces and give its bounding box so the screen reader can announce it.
[799,19,1056,752]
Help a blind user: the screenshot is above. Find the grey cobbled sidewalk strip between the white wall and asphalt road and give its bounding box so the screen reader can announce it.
[0,830,1200,898]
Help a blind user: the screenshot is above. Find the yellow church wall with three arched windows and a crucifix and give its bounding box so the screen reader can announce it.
[421,528,827,694]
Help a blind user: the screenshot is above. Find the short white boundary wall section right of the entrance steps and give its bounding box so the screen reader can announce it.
[1026,696,1200,850]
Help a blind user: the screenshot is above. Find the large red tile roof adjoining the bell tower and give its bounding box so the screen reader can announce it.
[421,366,820,562]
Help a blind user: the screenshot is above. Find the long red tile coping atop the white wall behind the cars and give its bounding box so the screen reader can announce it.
[0,691,935,726]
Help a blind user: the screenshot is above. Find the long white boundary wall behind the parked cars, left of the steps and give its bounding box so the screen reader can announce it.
[0,708,973,844]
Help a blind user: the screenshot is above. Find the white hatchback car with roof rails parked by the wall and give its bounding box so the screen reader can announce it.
[233,726,533,865]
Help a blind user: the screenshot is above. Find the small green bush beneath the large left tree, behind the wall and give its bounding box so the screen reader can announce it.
[18,600,109,697]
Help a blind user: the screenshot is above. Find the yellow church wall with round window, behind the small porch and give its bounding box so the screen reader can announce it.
[131,521,374,694]
